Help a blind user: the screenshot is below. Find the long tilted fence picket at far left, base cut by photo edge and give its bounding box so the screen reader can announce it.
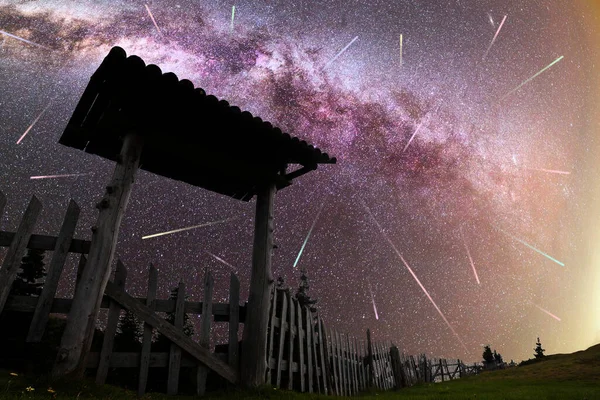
[0,196,42,314]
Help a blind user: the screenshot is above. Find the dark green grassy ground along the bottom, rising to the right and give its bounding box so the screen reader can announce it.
[0,345,600,400]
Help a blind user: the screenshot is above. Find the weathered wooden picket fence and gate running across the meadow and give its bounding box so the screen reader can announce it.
[0,192,481,396]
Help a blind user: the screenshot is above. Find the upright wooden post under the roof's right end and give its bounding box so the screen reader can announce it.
[240,184,276,387]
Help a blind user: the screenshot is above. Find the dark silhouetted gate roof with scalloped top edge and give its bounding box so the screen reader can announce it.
[59,47,336,201]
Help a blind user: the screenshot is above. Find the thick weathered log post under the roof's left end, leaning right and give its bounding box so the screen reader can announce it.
[52,134,143,378]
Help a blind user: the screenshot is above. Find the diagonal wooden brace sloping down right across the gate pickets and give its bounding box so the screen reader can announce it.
[106,282,238,384]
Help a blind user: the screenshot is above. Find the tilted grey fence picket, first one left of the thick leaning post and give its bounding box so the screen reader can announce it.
[27,200,80,343]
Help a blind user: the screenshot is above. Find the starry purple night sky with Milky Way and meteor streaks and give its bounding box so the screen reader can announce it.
[0,0,600,361]
